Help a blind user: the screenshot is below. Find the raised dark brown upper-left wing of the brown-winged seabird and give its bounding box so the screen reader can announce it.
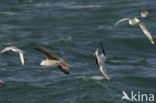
[34,48,59,60]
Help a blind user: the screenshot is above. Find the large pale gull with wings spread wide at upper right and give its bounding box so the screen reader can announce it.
[114,17,155,45]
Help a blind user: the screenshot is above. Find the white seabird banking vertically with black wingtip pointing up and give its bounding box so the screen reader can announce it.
[94,42,110,80]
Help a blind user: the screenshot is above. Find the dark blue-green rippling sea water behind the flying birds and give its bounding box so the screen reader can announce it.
[0,0,156,103]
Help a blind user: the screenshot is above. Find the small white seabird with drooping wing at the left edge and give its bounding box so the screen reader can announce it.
[0,46,24,65]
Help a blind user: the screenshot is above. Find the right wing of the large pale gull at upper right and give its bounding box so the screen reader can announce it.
[139,22,155,44]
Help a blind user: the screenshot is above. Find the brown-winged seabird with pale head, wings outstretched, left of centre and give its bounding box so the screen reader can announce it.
[34,48,69,74]
